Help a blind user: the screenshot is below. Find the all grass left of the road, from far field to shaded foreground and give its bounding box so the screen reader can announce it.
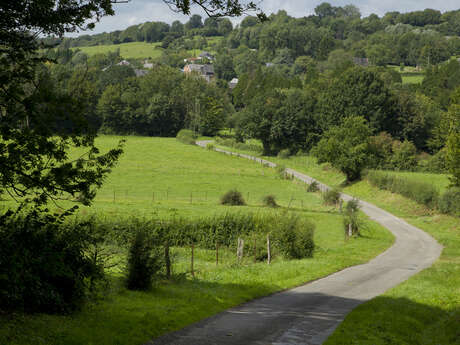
[0,136,393,345]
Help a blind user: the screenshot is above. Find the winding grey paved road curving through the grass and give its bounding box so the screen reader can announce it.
[148,141,442,345]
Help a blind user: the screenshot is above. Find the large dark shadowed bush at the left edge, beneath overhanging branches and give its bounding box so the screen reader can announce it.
[0,209,101,313]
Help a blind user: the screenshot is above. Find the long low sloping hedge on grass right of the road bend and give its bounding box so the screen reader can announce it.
[367,170,439,208]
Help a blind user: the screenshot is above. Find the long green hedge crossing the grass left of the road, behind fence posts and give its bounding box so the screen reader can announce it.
[108,211,315,257]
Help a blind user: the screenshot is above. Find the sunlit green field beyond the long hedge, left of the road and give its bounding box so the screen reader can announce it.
[74,136,348,217]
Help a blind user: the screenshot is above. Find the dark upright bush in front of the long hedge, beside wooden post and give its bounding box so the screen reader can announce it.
[126,229,163,290]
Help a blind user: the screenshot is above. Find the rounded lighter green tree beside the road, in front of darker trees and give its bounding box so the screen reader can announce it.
[313,116,372,182]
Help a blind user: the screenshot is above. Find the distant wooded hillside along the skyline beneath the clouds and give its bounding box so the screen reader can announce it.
[48,3,460,66]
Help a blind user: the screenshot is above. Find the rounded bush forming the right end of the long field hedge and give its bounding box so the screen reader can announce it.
[274,215,315,259]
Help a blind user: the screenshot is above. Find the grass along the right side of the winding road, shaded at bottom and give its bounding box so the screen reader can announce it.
[214,138,460,345]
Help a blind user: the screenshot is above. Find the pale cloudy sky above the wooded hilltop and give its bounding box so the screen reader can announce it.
[73,0,460,34]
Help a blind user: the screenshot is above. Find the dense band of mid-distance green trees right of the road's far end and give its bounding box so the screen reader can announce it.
[233,60,460,180]
